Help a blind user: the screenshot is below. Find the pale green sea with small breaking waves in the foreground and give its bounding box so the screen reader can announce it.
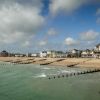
[0,62,100,100]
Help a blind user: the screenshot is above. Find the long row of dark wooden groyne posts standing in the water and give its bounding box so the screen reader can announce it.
[48,69,100,79]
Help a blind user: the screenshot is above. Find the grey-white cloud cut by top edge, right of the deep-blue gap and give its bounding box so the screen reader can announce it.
[49,0,88,15]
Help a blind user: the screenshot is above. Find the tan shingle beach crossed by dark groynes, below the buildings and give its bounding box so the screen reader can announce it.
[0,57,100,68]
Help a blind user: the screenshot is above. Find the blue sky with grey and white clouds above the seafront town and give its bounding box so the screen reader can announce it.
[0,0,100,53]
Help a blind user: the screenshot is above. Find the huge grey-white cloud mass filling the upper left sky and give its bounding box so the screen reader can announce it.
[0,0,44,43]
